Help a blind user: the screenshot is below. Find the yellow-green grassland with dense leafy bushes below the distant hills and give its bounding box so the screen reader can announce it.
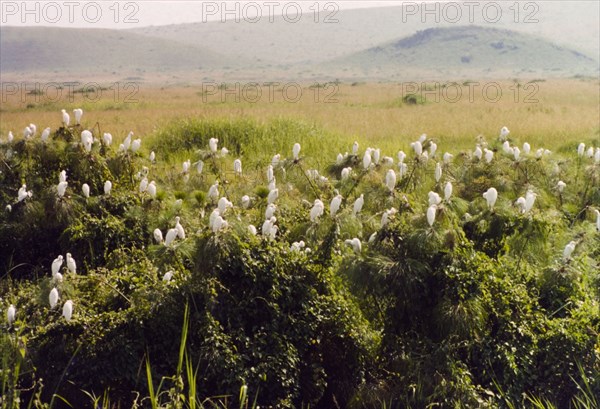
[0,79,600,409]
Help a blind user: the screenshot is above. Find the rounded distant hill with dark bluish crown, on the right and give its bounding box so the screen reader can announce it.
[328,26,599,79]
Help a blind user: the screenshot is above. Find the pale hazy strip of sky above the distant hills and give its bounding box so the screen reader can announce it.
[0,0,404,28]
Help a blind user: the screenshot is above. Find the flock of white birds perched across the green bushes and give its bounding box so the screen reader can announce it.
[1,109,600,325]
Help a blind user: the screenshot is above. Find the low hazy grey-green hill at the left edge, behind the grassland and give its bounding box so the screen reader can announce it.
[0,27,234,79]
